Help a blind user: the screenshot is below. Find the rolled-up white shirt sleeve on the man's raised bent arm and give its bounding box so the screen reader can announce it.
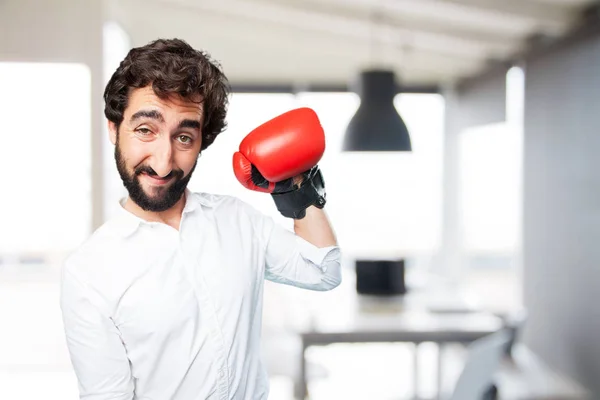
[265,219,342,291]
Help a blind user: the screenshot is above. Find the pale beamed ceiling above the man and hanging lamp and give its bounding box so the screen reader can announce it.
[107,0,594,87]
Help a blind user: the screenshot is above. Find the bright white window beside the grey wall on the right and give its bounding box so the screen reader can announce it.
[459,68,524,257]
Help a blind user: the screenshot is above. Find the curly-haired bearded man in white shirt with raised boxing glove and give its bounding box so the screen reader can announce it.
[61,40,341,400]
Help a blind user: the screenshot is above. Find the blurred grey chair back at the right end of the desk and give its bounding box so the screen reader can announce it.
[450,329,511,400]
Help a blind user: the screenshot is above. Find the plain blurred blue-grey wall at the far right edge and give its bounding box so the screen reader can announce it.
[523,29,600,398]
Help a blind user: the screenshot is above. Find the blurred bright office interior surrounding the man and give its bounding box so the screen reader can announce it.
[0,0,600,400]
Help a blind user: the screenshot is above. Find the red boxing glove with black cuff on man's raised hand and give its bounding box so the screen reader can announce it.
[233,108,325,218]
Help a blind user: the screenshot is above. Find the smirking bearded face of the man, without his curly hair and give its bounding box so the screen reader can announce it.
[109,86,202,212]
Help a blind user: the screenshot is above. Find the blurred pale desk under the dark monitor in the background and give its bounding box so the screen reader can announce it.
[297,270,503,399]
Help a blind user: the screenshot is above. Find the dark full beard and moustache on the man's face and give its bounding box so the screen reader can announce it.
[115,139,198,212]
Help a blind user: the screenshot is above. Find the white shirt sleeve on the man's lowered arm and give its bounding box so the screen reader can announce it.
[60,269,134,400]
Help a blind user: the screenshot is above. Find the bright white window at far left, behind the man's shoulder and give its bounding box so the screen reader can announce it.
[0,62,91,256]
